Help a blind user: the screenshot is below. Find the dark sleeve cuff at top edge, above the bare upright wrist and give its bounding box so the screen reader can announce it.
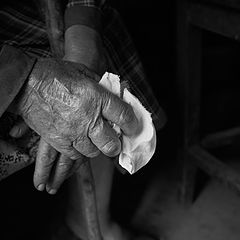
[64,0,105,32]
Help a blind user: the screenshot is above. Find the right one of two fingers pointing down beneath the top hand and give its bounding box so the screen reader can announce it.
[46,154,83,194]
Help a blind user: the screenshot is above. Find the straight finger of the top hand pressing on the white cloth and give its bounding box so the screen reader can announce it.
[102,93,138,135]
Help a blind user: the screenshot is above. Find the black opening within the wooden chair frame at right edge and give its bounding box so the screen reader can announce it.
[201,31,240,135]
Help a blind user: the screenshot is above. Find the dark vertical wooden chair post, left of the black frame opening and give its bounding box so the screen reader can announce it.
[177,1,202,206]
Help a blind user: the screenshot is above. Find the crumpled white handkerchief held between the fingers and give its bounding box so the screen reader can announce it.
[99,72,156,174]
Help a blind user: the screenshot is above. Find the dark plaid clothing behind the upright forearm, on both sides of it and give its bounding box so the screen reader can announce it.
[0,0,165,129]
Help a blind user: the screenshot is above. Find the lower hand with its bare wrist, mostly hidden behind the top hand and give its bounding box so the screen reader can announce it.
[7,25,109,193]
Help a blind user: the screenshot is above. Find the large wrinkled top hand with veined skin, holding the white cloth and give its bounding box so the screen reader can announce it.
[16,59,138,159]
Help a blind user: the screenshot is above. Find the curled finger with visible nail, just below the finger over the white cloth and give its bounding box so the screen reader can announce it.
[89,118,121,157]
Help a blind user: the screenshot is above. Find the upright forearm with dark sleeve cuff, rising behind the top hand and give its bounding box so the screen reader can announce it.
[65,1,105,74]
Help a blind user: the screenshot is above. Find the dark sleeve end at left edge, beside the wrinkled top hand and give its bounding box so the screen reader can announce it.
[0,45,36,117]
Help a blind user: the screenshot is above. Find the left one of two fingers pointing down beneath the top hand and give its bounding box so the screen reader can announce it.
[33,138,58,191]
